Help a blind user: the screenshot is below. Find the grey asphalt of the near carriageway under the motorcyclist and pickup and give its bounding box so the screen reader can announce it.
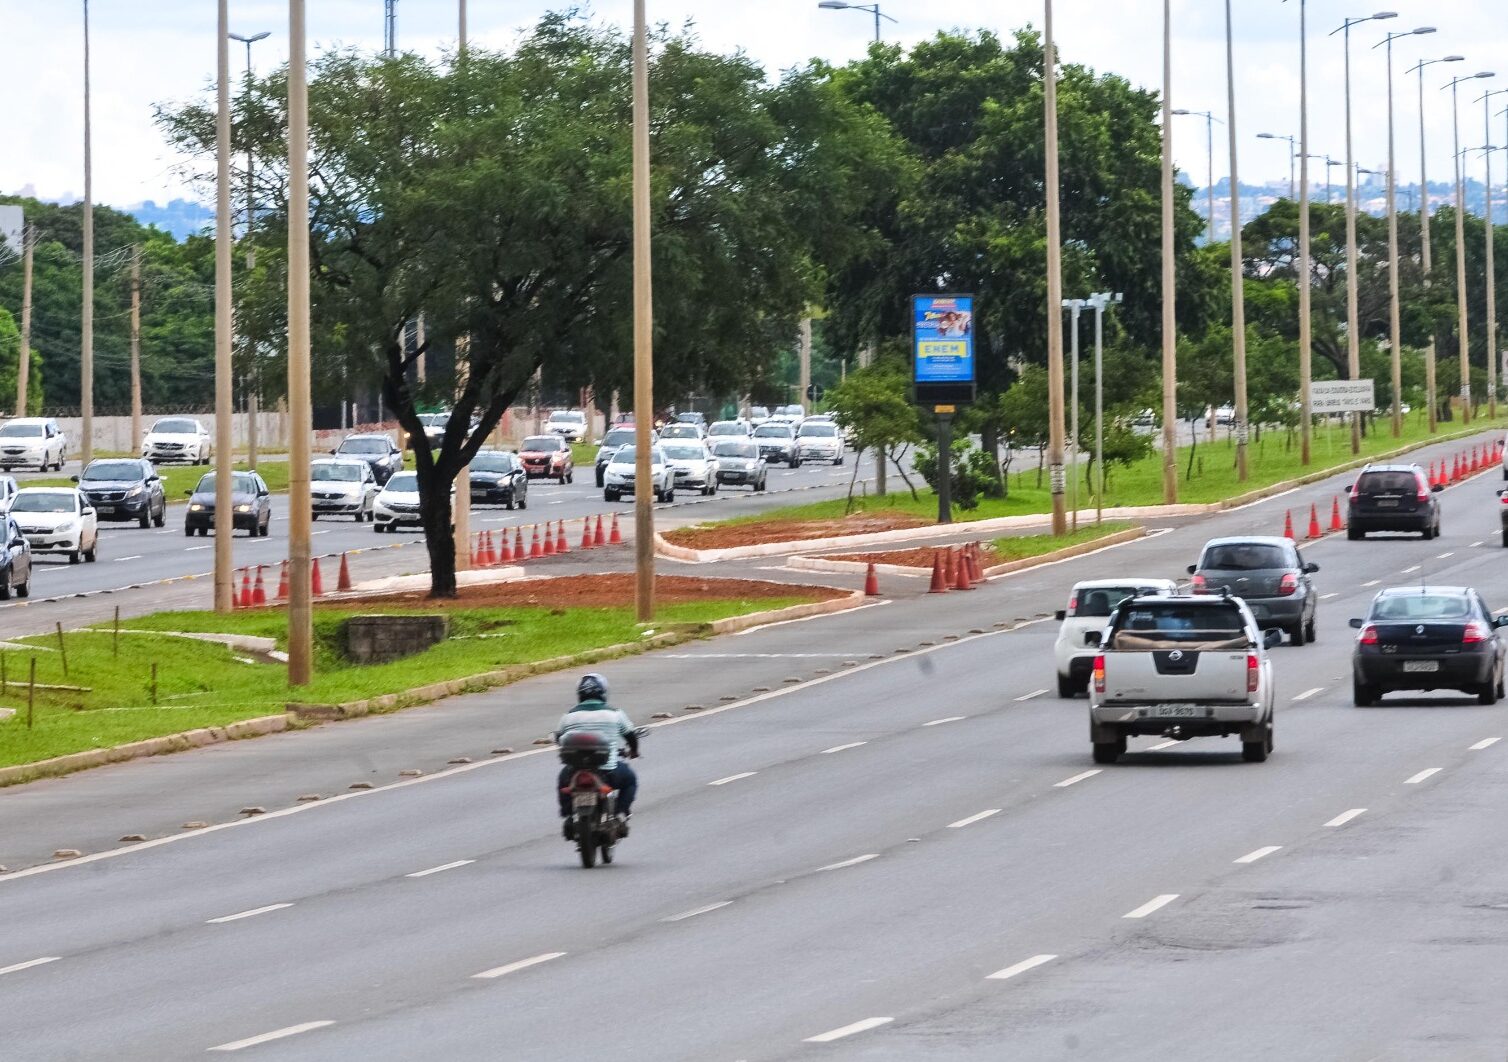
[0,428,1508,1060]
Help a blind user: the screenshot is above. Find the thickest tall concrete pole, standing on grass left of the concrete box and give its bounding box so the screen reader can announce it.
[288,0,314,686]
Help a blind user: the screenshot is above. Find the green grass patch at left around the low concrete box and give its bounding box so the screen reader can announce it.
[0,594,810,766]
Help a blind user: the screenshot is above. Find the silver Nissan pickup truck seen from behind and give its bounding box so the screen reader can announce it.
[1089,594,1282,763]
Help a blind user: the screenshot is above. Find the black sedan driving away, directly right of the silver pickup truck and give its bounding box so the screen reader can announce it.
[1351,587,1508,707]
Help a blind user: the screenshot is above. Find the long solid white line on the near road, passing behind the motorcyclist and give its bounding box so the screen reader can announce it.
[0,621,1043,884]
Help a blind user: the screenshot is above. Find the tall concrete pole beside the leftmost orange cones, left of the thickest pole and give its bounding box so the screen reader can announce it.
[214,0,235,612]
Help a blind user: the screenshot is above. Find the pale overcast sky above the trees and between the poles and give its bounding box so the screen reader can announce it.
[0,0,1508,205]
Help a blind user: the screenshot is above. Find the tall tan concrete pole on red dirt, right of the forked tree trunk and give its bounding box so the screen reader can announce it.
[633,0,654,623]
